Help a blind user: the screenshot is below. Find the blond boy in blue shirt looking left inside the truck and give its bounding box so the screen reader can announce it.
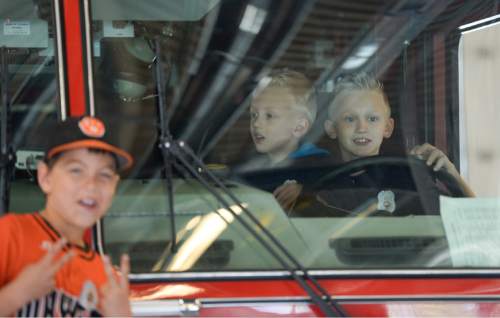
[250,69,329,209]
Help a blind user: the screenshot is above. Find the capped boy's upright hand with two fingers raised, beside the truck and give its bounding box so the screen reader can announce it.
[101,255,132,317]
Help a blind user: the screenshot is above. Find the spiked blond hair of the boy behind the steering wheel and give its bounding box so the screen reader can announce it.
[328,72,391,120]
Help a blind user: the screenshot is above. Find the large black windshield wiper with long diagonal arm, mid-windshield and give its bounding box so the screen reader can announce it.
[155,39,346,317]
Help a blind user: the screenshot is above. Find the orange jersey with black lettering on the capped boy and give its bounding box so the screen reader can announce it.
[0,213,107,317]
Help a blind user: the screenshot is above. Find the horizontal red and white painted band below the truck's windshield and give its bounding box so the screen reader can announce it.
[130,278,500,317]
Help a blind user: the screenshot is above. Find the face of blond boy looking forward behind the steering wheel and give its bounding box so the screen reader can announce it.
[325,90,394,162]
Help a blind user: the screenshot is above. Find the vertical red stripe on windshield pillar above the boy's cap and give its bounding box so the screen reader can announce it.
[63,0,86,117]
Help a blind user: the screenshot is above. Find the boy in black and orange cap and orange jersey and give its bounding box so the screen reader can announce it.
[0,117,133,316]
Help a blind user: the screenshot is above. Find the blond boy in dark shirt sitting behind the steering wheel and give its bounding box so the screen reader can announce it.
[291,73,472,217]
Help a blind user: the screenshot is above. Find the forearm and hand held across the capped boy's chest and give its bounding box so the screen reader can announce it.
[0,238,74,313]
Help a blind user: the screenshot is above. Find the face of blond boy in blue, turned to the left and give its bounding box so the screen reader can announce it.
[250,87,309,163]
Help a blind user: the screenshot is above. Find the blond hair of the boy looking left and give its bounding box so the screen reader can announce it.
[256,68,317,125]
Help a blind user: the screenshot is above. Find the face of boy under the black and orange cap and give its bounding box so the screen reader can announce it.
[38,148,119,241]
